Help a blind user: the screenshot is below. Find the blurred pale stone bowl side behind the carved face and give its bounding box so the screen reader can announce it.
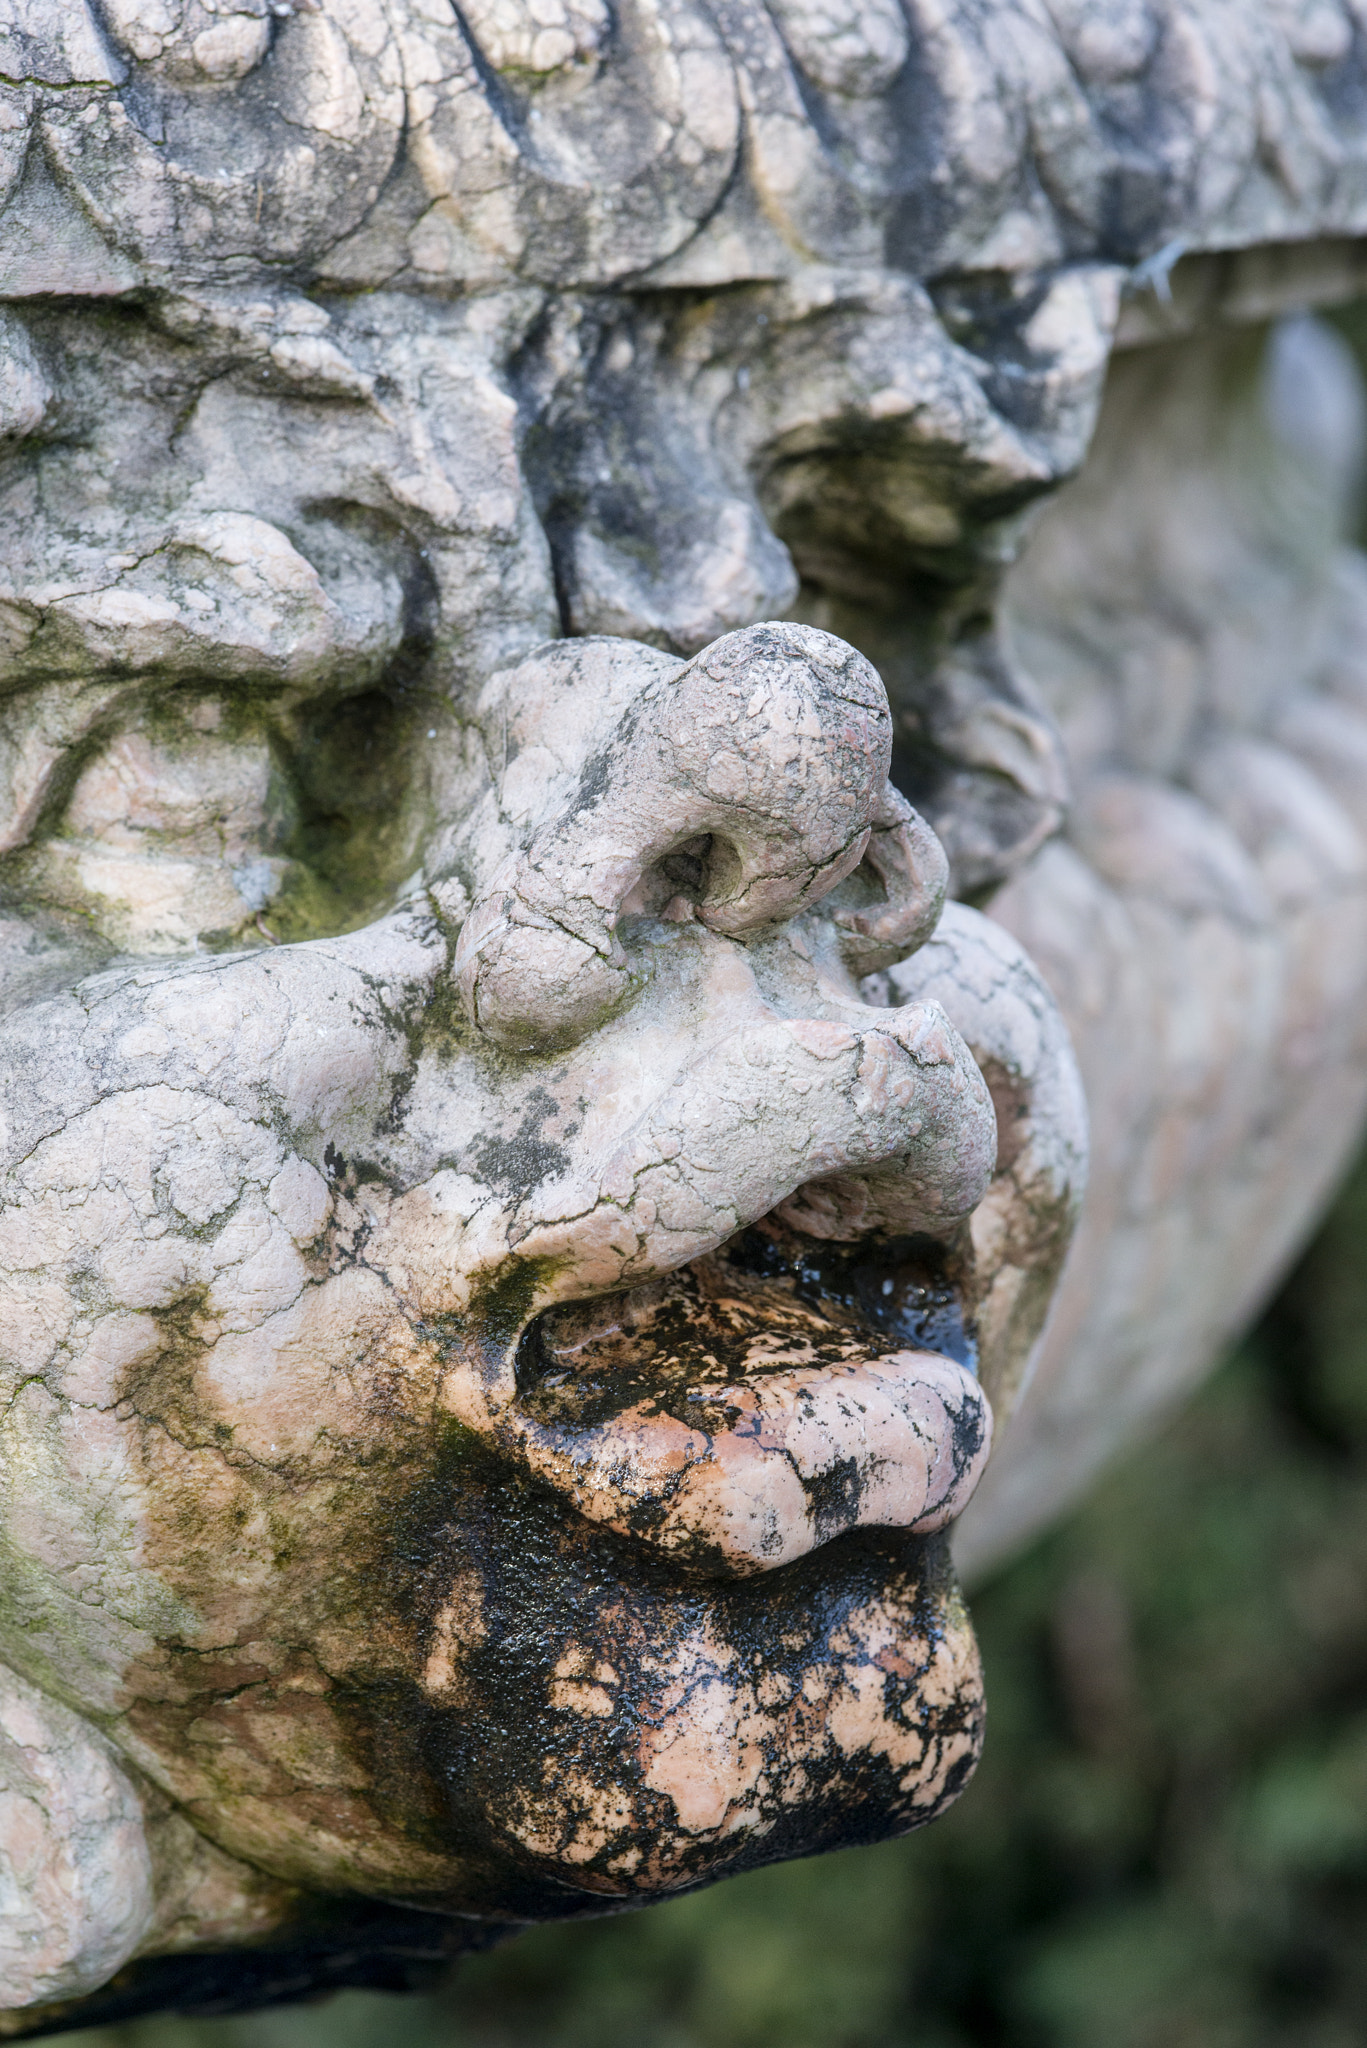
[959,322,1367,1569]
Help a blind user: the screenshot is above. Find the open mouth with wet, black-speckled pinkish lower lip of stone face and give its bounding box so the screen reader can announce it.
[504,1219,992,1577]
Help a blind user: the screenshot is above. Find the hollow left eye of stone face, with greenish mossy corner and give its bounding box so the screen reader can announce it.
[0,684,437,954]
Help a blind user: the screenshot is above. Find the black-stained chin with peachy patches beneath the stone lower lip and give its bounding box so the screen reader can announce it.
[395,1442,982,1919]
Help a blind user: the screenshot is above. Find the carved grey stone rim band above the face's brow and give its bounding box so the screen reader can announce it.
[0,0,1363,293]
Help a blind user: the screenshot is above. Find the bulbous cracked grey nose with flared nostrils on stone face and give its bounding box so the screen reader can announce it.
[455,625,945,1051]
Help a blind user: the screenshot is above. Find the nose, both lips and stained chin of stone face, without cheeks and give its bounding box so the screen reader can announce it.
[305,629,1037,1917]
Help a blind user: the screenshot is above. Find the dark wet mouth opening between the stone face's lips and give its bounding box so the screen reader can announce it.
[516,1219,978,1430]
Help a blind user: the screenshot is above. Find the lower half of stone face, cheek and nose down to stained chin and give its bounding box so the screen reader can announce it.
[0,606,1082,2005]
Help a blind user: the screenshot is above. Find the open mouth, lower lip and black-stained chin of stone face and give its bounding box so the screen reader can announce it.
[422,1212,990,1917]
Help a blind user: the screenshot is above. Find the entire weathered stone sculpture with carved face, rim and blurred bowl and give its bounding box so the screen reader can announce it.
[0,0,1367,2036]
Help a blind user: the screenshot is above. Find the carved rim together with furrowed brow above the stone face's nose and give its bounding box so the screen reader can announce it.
[10,0,1367,915]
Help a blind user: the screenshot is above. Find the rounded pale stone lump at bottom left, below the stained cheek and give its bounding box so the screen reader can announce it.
[0,1665,154,2011]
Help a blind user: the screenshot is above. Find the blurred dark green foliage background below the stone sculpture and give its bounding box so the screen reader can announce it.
[66,1161,1367,2048]
